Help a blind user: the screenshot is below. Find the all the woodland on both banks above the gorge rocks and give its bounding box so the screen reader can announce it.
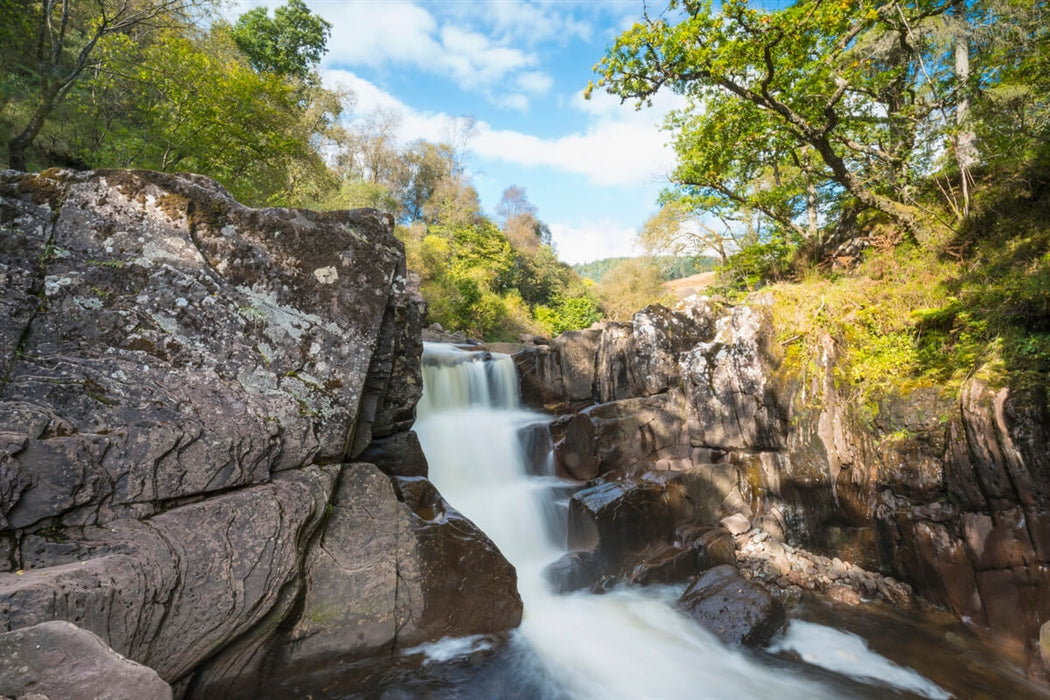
[0,0,1050,369]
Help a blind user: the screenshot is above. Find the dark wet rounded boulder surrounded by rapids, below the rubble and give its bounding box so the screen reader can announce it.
[678,565,786,646]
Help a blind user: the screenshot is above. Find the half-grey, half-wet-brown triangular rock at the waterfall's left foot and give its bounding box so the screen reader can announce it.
[280,464,522,669]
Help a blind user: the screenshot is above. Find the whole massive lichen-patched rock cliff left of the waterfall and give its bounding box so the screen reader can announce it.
[0,170,521,696]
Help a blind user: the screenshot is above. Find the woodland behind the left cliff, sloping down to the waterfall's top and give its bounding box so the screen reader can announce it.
[0,0,662,340]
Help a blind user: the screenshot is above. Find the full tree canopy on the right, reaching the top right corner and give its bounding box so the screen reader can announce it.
[589,0,1050,279]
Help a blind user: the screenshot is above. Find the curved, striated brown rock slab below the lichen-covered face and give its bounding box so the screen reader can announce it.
[0,467,334,682]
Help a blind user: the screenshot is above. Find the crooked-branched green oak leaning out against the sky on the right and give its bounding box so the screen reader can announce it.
[589,0,951,242]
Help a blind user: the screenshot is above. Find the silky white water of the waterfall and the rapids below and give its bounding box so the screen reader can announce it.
[415,344,948,699]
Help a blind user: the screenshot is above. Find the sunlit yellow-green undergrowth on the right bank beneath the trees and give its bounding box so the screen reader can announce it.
[768,165,1050,411]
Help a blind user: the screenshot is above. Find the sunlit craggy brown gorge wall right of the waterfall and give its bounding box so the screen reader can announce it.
[515,297,1050,675]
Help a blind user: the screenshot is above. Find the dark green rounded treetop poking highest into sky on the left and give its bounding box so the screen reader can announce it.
[233,0,332,80]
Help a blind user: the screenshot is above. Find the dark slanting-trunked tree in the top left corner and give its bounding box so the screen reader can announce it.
[0,0,208,170]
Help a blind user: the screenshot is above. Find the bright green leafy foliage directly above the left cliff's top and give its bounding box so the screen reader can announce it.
[0,0,342,205]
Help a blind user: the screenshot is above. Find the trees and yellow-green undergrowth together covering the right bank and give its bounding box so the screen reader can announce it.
[588,0,1050,398]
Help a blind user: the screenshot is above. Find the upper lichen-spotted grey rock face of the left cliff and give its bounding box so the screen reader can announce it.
[0,171,405,528]
